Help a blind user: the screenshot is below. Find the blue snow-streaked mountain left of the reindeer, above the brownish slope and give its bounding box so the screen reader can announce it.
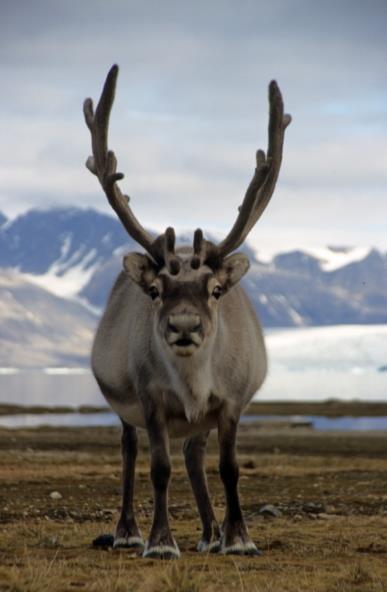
[0,208,135,296]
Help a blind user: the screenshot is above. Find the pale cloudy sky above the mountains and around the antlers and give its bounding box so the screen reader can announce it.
[0,0,387,249]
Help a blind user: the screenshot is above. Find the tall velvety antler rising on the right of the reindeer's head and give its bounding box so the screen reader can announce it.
[213,80,291,257]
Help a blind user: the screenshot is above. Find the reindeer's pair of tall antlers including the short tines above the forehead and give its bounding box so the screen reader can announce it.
[83,65,291,275]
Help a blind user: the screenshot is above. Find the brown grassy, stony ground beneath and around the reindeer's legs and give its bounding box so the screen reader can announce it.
[0,418,387,592]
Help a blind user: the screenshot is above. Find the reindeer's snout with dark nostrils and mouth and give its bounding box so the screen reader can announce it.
[166,312,202,356]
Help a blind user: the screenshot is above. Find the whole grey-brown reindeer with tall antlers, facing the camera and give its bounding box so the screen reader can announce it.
[84,65,291,558]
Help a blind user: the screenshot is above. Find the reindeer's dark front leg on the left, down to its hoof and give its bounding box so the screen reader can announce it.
[143,411,180,559]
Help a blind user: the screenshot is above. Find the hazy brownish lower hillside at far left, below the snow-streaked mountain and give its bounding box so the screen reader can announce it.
[0,270,97,368]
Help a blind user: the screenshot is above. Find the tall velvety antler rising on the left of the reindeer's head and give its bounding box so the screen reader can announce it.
[83,65,163,263]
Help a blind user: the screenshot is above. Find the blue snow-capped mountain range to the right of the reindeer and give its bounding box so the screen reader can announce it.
[245,249,387,327]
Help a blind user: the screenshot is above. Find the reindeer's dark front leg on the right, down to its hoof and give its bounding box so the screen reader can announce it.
[218,409,260,555]
